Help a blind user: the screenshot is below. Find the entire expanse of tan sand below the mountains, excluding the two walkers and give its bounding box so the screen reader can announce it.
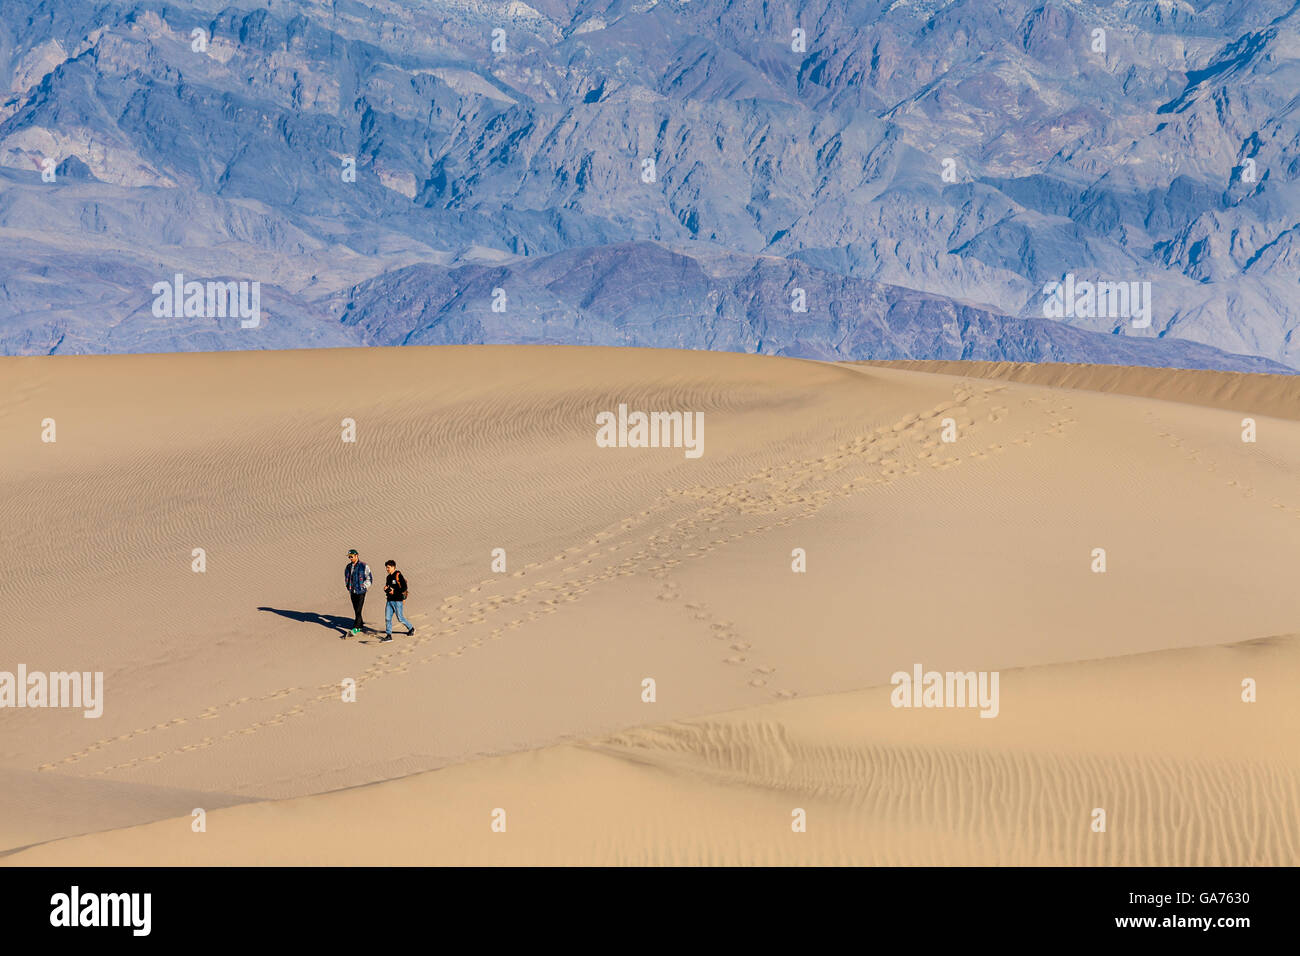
[0,347,1300,864]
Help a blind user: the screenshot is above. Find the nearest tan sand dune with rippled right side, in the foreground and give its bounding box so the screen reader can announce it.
[8,636,1300,865]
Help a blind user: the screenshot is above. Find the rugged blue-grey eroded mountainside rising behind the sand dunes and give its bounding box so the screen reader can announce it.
[0,0,1300,368]
